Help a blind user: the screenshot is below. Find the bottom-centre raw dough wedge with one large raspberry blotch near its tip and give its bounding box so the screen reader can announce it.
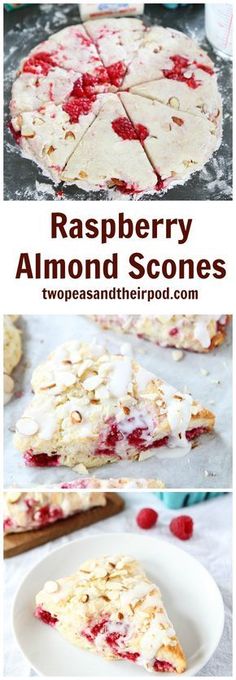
[62,94,157,194]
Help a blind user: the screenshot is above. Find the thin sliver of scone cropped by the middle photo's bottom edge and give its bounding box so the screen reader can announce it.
[61,477,165,489]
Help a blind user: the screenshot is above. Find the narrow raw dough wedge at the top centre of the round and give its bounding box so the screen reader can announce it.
[84,17,145,87]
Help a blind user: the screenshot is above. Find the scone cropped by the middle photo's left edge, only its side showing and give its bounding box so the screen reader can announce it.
[3,315,22,404]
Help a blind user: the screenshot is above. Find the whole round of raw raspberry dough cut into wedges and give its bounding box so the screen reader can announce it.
[10,17,222,197]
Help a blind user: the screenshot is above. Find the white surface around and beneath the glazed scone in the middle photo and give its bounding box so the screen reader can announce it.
[4,315,232,489]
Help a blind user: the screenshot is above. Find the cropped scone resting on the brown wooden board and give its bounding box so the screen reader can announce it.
[3,489,106,534]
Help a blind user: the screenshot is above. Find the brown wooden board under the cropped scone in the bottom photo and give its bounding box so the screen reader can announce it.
[4,493,124,557]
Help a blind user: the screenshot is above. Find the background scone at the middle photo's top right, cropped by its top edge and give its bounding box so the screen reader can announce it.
[92,314,229,352]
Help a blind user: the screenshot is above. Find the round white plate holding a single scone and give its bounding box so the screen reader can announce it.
[13,533,224,678]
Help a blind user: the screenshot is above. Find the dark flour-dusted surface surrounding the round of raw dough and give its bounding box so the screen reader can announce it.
[4,3,232,201]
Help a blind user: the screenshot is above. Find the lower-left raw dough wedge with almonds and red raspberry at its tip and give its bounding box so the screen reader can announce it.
[12,95,102,182]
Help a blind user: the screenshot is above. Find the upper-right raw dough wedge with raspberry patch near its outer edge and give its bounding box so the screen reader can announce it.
[121,26,214,90]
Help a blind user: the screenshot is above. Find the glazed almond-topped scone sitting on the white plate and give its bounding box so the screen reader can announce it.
[35,555,186,673]
